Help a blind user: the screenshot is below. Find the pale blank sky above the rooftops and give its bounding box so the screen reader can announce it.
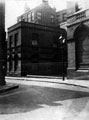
[5,0,82,31]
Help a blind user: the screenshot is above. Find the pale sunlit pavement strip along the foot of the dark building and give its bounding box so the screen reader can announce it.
[6,75,89,88]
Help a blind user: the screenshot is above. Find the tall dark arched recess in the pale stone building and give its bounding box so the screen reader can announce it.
[74,23,89,69]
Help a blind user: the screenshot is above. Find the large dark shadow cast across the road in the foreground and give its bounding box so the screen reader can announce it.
[0,85,89,114]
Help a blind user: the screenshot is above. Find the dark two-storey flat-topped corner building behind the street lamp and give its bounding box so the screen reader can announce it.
[7,21,67,76]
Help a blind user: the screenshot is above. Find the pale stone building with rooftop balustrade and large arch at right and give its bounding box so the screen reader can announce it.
[67,0,89,78]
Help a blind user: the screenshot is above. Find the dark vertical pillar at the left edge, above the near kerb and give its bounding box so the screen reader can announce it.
[0,0,6,86]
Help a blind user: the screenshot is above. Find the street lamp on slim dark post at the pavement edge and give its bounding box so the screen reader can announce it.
[59,34,66,81]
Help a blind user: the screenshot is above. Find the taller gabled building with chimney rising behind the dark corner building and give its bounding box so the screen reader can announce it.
[17,0,57,26]
